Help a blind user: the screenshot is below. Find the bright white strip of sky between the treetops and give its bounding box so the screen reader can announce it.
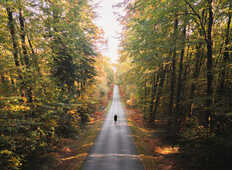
[94,0,123,63]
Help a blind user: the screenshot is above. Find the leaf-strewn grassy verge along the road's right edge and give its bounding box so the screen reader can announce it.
[120,87,178,170]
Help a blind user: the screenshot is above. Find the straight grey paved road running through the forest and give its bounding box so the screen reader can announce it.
[82,86,144,170]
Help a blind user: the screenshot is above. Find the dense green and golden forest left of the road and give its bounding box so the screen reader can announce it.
[0,0,113,170]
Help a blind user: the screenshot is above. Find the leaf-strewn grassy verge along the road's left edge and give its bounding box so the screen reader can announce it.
[55,99,112,170]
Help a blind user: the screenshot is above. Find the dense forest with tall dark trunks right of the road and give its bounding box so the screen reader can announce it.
[117,0,232,170]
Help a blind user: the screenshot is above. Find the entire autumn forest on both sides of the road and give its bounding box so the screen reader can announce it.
[0,0,232,170]
